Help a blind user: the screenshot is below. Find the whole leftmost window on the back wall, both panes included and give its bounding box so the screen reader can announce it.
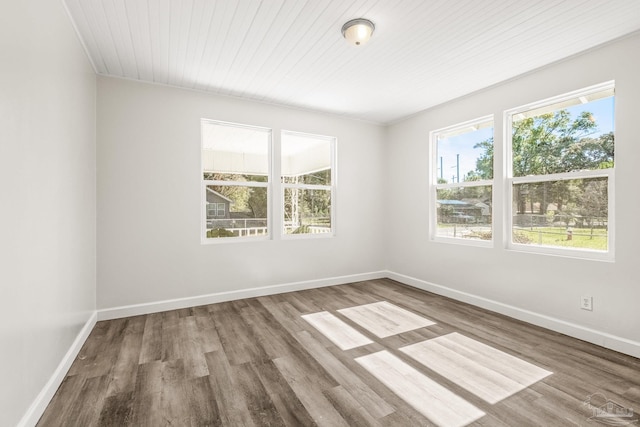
[201,119,271,241]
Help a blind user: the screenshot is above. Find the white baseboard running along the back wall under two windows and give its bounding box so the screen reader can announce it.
[98,271,387,320]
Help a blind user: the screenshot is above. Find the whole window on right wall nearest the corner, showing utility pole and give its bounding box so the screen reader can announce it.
[430,116,493,245]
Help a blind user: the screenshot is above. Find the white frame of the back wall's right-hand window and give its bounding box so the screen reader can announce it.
[279,129,338,240]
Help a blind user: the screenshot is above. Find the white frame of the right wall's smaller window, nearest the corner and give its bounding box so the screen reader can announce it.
[429,114,496,247]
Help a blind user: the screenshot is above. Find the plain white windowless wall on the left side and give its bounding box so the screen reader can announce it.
[0,0,96,426]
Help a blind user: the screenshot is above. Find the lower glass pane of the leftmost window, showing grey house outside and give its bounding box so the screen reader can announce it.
[206,185,268,238]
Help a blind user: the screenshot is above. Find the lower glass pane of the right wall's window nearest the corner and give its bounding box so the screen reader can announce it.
[436,185,492,240]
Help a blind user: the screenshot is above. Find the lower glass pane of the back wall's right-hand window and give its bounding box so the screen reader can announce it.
[284,188,331,234]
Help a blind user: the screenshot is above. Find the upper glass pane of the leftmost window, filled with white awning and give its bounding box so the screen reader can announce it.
[202,120,271,182]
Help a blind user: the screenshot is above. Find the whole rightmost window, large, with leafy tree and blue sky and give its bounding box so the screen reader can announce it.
[505,82,614,258]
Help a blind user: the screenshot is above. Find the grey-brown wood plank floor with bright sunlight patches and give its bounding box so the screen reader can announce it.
[38,279,640,427]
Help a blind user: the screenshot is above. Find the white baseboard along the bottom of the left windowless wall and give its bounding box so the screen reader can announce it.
[18,311,98,427]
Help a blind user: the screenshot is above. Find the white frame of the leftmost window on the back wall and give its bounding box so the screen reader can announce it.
[199,119,274,244]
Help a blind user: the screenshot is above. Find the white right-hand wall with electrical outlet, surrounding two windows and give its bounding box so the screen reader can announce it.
[387,35,640,351]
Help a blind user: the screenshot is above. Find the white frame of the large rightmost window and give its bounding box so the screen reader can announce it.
[503,81,615,261]
